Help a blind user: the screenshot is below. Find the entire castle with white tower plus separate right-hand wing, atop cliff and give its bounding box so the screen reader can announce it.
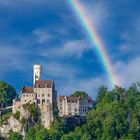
[12,65,94,128]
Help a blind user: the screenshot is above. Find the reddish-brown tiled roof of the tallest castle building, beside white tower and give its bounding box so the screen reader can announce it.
[35,80,53,88]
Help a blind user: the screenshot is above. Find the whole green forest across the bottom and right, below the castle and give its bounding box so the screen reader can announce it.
[1,83,140,140]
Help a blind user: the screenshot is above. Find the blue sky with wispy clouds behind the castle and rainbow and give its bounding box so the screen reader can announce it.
[0,0,140,98]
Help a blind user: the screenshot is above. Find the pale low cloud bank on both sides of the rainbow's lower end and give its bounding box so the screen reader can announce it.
[59,57,140,99]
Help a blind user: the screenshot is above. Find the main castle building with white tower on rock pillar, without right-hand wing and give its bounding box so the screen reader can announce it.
[12,65,57,128]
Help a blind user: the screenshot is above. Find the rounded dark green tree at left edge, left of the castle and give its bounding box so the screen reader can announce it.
[0,81,16,107]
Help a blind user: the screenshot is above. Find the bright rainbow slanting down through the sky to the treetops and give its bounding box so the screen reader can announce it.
[68,0,119,87]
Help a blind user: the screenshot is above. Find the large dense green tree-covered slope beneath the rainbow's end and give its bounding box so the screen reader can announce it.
[62,84,140,140]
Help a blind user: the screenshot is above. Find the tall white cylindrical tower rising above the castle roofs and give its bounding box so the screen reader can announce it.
[34,64,42,85]
